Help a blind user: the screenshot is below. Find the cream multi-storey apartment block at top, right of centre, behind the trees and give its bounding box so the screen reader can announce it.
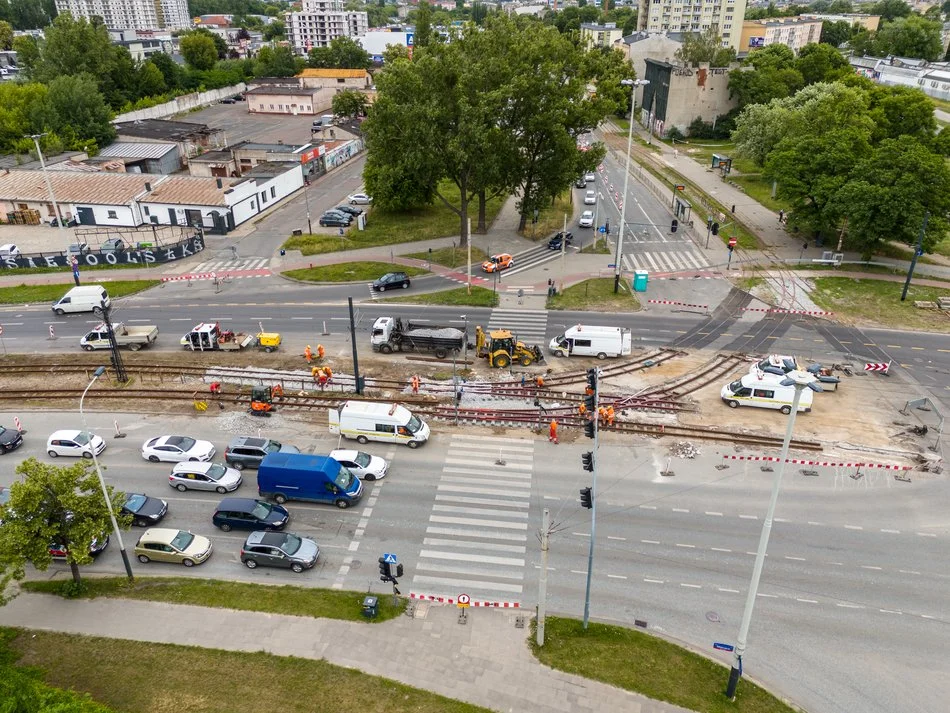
[637,0,746,52]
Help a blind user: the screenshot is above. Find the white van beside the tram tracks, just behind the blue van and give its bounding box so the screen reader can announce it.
[329,401,429,448]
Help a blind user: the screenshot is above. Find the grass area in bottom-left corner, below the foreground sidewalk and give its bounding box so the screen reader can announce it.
[5,629,487,713]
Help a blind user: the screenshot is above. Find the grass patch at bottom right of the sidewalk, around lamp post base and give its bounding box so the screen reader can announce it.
[530,617,794,713]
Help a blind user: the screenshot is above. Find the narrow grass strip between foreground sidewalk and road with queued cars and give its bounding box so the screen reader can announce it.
[20,577,405,622]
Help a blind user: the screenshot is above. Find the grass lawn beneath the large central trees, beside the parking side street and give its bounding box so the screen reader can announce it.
[282,182,505,255]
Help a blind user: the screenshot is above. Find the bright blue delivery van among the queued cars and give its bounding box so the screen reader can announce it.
[257,452,363,508]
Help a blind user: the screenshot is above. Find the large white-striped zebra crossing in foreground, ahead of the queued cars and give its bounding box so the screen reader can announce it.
[411,434,534,603]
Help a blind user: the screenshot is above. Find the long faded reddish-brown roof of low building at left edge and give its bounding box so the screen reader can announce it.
[0,171,158,205]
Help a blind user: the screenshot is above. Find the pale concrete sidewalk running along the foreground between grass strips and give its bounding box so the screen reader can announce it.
[0,594,686,713]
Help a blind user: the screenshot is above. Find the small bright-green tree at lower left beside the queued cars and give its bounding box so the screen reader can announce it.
[0,458,131,591]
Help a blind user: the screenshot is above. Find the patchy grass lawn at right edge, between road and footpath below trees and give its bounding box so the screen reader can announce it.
[811,277,950,332]
